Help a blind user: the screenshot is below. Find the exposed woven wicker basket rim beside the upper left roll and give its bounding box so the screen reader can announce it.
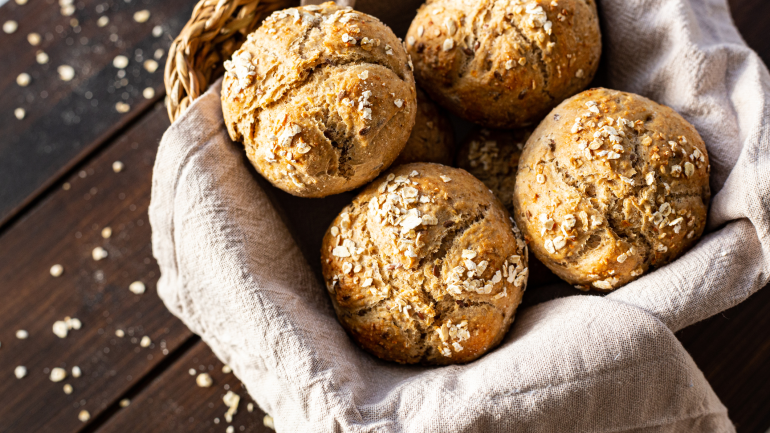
[164,0,297,122]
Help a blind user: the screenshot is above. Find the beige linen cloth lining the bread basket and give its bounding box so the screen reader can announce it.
[150,0,770,433]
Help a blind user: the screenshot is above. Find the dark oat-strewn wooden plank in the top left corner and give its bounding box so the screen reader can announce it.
[0,0,194,224]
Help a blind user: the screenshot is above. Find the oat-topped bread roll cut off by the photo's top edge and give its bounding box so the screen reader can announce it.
[407,0,602,128]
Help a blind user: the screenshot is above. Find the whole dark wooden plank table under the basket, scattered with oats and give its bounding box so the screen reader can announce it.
[0,0,770,433]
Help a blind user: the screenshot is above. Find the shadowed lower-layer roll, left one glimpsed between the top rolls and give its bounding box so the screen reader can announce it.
[393,88,455,165]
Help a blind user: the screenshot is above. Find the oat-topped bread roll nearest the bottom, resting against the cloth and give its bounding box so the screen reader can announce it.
[321,163,529,364]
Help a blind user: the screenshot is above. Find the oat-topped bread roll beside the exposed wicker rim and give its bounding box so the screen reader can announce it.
[222,3,417,197]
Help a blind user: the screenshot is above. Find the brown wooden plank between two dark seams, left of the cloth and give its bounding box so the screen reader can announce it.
[0,106,192,432]
